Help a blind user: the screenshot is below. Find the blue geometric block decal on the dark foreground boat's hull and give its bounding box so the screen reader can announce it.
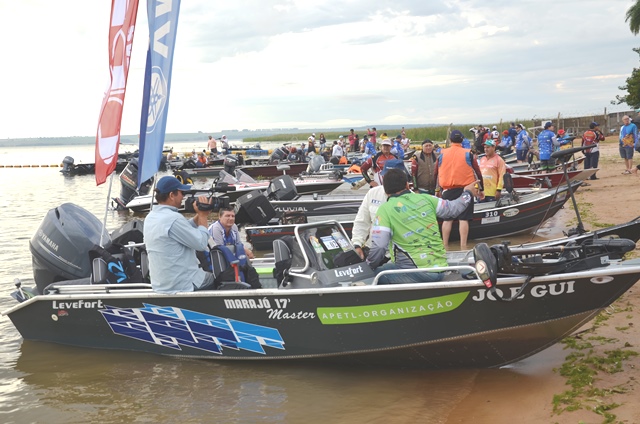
[100,303,284,355]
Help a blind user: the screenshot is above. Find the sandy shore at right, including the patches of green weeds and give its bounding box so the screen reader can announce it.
[446,137,640,424]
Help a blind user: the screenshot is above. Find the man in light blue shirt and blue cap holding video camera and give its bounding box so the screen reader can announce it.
[143,176,213,293]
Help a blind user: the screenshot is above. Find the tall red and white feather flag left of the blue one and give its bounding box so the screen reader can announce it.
[96,0,138,185]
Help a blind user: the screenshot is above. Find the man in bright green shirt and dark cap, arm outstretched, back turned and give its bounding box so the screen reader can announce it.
[367,169,477,284]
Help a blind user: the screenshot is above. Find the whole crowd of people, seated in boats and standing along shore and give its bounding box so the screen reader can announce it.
[144,117,640,293]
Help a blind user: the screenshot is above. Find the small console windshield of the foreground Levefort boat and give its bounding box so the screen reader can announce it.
[298,222,362,271]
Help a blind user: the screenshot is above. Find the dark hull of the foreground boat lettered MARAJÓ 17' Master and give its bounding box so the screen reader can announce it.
[4,263,640,368]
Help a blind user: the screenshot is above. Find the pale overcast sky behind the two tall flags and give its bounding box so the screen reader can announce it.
[0,0,640,138]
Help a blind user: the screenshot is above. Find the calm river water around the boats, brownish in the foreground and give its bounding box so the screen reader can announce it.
[0,143,571,423]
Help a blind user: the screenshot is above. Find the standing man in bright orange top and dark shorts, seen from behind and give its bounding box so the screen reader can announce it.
[435,130,484,250]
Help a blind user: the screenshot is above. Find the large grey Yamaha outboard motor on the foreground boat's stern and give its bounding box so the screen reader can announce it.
[29,203,111,293]
